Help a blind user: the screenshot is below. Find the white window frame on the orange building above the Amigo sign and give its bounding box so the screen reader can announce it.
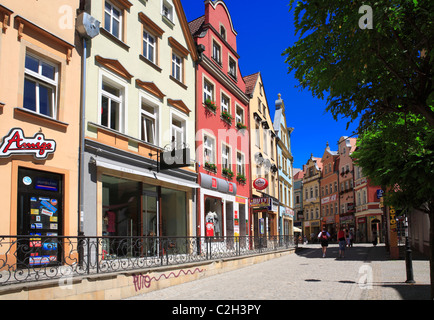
[23,52,59,119]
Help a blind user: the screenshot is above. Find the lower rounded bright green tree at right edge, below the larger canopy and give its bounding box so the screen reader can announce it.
[352,113,434,298]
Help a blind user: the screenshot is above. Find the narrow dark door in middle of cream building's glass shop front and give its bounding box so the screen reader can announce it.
[142,192,160,256]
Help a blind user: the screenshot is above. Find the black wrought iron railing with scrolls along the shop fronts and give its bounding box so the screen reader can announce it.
[0,235,294,286]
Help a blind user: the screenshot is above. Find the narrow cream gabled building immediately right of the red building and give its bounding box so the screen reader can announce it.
[244,72,279,236]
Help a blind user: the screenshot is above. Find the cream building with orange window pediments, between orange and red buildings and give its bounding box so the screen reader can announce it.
[82,0,198,240]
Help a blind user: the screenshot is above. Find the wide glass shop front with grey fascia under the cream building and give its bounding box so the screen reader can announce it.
[83,140,198,246]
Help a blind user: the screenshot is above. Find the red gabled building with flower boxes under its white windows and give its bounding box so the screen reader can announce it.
[189,1,251,236]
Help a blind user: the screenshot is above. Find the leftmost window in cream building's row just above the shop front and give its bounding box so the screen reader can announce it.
[101,81,123,131]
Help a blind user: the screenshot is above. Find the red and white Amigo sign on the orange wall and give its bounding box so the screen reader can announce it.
[0,128,56,160]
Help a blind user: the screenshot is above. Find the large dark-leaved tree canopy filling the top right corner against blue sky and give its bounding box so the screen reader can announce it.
[283,0,434,132]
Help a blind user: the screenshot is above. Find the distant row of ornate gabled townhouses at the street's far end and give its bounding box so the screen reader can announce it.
[294,136,385,242]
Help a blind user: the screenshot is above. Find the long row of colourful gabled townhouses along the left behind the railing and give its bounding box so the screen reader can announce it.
[0,0,293,261]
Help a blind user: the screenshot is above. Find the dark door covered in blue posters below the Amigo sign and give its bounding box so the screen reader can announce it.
[17,168,63,267]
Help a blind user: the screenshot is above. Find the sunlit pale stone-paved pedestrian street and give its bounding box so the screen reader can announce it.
[129,244,430,300]
